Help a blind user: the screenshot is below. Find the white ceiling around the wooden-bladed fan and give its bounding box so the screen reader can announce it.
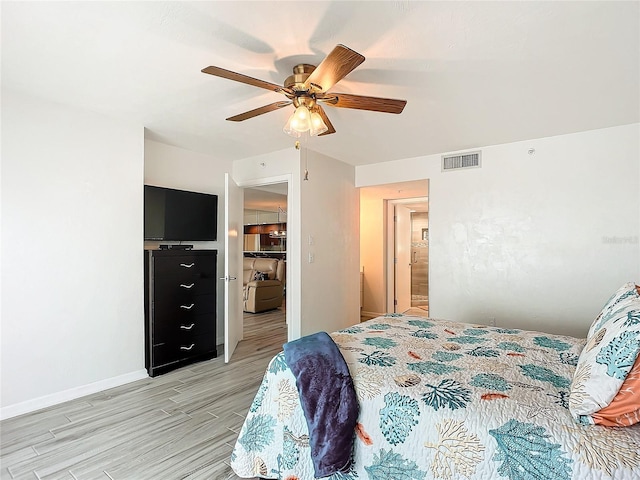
[0,1,640,165]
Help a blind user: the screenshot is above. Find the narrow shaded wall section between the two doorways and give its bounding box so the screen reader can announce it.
[300,151,360,335]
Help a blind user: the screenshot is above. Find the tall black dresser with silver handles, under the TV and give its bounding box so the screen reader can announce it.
[144,250,218,377]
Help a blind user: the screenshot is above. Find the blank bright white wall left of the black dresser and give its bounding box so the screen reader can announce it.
[0,90,146,418]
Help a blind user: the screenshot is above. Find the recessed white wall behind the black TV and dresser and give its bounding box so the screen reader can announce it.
[144,140,232,345]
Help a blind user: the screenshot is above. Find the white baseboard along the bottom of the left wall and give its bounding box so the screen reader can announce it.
[0,369,149,420]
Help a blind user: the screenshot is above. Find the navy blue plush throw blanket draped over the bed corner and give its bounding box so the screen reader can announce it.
[284,332,358,478]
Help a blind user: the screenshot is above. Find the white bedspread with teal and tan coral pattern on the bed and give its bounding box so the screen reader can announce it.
[231,314,640,480]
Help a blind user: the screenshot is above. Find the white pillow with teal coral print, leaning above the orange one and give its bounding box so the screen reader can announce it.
[569,284,640,424]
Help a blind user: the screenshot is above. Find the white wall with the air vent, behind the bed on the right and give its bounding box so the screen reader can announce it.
[356,124,640,336]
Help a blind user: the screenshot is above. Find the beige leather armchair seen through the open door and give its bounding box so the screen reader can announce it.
[242,257,285,313]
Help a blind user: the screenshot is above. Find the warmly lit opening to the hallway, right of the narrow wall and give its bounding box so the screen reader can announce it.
[360,179,429,320]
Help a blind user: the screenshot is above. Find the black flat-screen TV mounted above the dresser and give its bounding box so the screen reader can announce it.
[144,185,218,241]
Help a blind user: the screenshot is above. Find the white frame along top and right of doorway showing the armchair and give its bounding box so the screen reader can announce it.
[238,174,294,341]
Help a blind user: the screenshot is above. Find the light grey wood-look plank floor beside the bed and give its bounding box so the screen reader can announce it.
[0,310,287,480]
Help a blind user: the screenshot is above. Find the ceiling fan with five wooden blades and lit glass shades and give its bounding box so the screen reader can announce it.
[202,45,407,137]
